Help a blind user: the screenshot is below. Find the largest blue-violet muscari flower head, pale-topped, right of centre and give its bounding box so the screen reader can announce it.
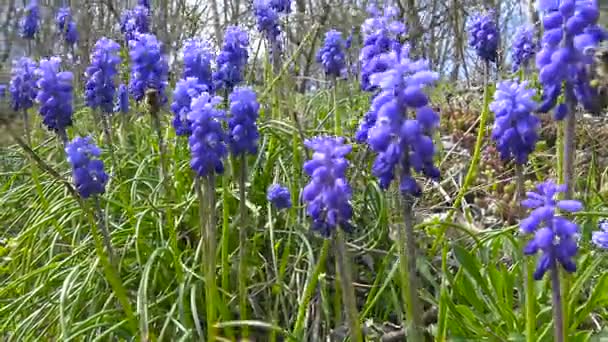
[367,44,439,196]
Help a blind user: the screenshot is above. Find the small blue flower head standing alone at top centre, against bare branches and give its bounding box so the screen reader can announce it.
[317,30,346,78]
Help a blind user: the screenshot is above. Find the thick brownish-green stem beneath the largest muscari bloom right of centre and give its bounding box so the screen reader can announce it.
[398,195,422,341]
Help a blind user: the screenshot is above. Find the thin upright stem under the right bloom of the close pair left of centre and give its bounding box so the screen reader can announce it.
[239,154,248,338]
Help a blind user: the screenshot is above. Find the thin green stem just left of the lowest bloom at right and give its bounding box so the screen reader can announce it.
[515,164,536,342]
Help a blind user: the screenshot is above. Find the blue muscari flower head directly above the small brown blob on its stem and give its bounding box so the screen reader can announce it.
[129,34,169,104]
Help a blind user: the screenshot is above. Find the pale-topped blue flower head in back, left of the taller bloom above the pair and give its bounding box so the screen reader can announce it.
[183,38,213,92]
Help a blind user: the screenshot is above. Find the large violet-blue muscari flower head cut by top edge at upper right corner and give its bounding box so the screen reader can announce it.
[536,0,606,116]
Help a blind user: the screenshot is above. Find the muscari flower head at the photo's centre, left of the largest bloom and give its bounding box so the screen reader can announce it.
[302,137,353,237]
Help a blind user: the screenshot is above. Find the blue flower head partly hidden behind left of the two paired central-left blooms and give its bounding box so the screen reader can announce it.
[171,77,207,136]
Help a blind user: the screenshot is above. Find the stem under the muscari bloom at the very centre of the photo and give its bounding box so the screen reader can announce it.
[335,228,363,342]
